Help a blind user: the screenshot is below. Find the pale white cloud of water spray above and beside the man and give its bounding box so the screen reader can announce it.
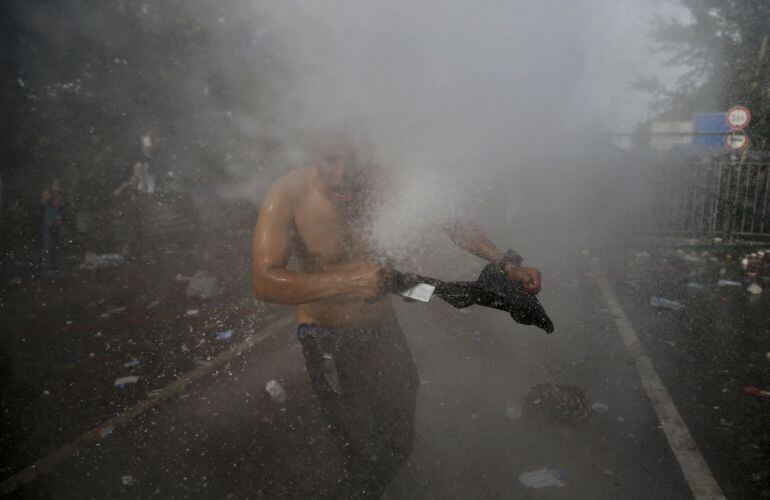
[242,0,675,264]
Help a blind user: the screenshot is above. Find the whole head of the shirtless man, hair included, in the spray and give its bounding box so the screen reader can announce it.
[313,132,369,204]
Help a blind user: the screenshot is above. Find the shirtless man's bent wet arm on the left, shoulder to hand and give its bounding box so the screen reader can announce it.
[252,174,384,304]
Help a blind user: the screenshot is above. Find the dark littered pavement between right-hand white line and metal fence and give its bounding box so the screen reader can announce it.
[613,244,770,498]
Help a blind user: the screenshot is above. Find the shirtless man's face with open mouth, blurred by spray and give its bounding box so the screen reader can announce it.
[316,141,367,204]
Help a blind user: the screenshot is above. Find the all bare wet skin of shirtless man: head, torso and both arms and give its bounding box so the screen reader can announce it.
[252,143,540,327]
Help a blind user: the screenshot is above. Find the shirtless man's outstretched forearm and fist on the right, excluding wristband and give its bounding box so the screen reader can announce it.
[445,221,540,293]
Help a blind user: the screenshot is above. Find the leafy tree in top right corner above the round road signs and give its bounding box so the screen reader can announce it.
[643,0,770,149]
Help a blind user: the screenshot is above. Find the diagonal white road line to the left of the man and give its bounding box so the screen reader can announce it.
[0,315,296,496]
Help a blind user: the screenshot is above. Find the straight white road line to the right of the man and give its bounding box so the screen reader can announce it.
[596,271,725,500]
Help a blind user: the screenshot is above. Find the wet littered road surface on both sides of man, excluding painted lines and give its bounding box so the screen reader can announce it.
[3,244,770,499]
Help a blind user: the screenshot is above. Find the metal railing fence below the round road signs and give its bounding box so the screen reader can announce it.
[635,159,770,239]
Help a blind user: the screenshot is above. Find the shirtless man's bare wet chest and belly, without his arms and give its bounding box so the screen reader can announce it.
[292,168,394,327]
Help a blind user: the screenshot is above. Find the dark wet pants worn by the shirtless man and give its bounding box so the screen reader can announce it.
[298,319,419,498]
